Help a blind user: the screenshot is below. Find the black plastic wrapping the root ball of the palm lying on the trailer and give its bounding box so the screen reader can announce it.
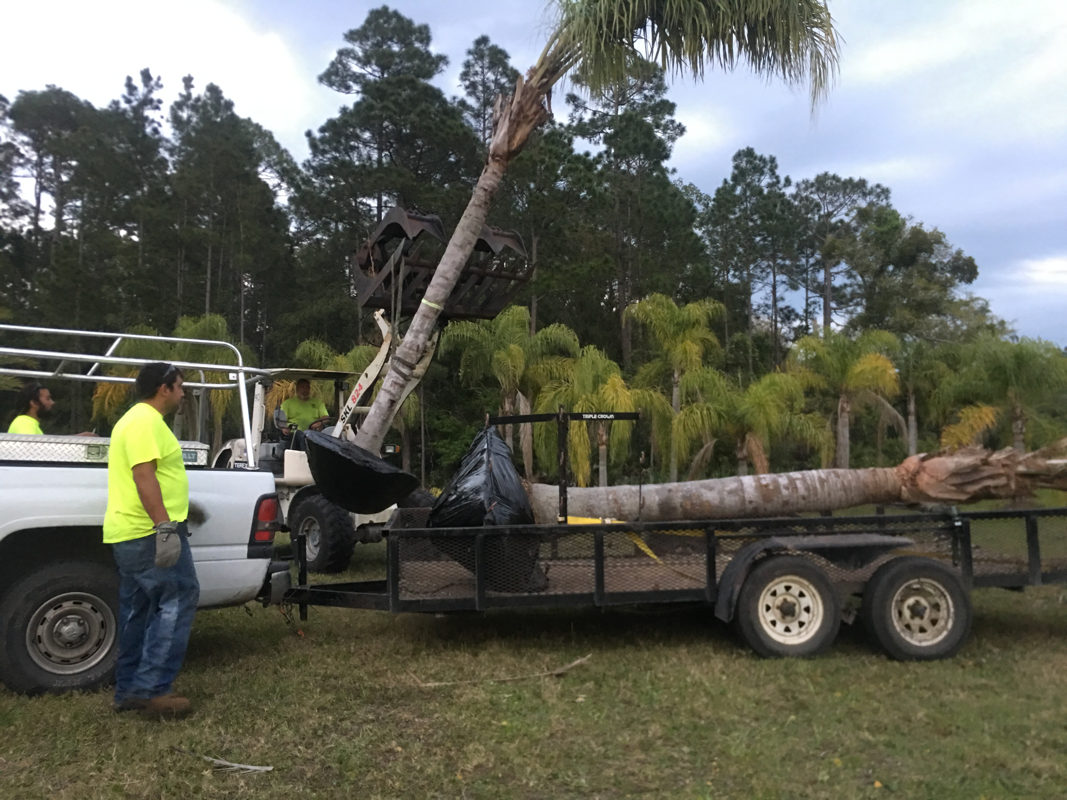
[430,428,547,592]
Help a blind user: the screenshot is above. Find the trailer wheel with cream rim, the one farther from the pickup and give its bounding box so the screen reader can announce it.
[860,556,973,661]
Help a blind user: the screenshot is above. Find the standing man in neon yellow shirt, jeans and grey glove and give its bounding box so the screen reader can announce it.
[103,363,200,718]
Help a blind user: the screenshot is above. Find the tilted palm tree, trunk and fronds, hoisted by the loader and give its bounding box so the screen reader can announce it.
[356,0,838,452]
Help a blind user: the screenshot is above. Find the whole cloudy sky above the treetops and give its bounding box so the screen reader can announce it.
[0,0,1067,345]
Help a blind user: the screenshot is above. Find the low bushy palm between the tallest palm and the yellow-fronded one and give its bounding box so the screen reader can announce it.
[671,367,832,480]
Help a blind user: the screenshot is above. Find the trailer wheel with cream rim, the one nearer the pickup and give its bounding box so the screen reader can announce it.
[736,556,841,658]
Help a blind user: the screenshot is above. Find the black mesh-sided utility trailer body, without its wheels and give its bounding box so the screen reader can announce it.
[289,509,1067,612]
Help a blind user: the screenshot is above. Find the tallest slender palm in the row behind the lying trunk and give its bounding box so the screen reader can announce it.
[625,294,726,481]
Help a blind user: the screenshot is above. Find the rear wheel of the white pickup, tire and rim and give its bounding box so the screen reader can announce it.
[0,561,118,694]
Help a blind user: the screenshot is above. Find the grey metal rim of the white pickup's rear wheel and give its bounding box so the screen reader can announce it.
[26,592,117,675]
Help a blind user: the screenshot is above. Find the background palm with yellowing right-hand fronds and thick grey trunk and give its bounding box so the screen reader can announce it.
[790,331,903,469]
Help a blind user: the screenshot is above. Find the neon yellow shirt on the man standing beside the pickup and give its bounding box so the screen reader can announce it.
[103,403,189,544]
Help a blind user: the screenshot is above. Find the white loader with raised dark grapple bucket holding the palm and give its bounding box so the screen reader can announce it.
[211,207,532,572]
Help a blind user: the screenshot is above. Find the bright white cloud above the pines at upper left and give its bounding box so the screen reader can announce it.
[0,0,337,157]
